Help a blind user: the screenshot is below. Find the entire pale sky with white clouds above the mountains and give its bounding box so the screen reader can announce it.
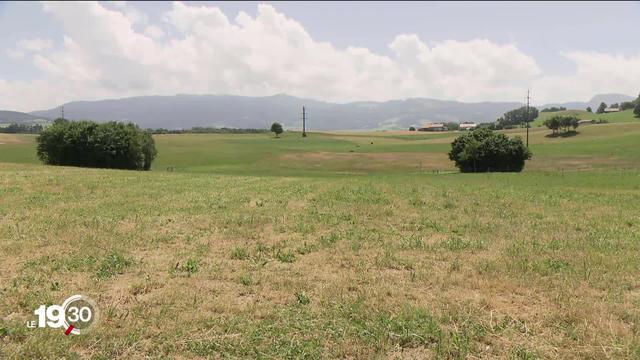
[0,2,640,111]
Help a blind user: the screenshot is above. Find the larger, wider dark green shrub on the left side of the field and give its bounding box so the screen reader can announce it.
[37,119,157,170]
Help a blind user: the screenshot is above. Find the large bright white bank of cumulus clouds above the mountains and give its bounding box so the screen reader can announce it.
[0,2,640,110]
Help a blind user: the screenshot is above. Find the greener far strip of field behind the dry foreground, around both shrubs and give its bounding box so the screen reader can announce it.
[0,121,640,176]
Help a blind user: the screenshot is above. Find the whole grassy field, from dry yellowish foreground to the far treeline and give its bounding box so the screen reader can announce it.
[0,125,640,359]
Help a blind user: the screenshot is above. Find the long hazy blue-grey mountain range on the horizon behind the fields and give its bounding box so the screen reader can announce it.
[31,95,522,130]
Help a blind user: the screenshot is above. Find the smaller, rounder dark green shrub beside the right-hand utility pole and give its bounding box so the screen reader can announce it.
[449,128,531,172]
